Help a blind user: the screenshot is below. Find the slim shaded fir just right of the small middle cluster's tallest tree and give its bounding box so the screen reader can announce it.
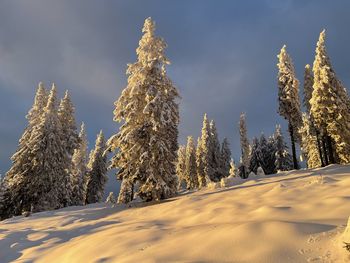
[209,120,223,182]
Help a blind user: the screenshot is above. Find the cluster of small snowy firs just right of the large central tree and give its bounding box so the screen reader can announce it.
[176,114,231,190]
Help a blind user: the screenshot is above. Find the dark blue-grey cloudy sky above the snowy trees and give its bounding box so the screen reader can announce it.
[0,0,350,192]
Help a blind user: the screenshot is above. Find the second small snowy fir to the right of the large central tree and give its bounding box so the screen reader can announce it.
[184,136,199,190]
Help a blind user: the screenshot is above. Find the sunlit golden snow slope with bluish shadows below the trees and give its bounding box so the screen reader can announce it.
[0,165,350,263]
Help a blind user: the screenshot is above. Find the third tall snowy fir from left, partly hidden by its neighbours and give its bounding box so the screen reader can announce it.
[58,91,79,204]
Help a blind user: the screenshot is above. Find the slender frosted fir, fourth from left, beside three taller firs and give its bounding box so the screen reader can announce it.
[71,123,88,205]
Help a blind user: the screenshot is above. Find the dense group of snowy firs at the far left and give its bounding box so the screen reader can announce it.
[0,83,107,219]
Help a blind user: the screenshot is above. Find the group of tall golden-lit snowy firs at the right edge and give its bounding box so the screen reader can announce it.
[277,30,350,168]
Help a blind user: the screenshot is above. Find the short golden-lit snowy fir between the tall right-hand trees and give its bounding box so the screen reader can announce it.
[299,113,322,168]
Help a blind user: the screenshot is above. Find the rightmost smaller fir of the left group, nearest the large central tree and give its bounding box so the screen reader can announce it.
[85,131,108,204]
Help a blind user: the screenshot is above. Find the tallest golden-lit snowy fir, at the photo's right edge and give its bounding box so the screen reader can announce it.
[310,30,350,163]
